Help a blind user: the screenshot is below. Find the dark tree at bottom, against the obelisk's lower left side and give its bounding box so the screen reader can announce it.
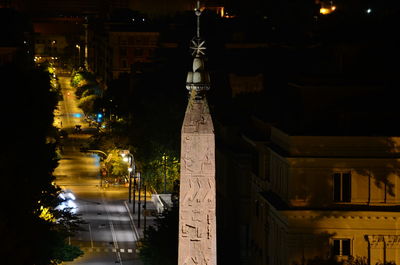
[139,204,179,265]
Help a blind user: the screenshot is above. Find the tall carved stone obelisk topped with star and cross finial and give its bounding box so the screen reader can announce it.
[178,1,217,265]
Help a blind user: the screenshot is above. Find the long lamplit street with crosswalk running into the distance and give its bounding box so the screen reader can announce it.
[54,73,142,265]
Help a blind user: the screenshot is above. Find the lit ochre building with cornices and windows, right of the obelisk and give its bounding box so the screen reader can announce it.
[243,121,400,264]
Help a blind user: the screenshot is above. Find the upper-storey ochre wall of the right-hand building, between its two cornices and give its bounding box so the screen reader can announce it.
[288,158,400,207]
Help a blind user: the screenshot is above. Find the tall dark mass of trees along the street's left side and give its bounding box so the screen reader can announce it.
[0,65,83,265]
